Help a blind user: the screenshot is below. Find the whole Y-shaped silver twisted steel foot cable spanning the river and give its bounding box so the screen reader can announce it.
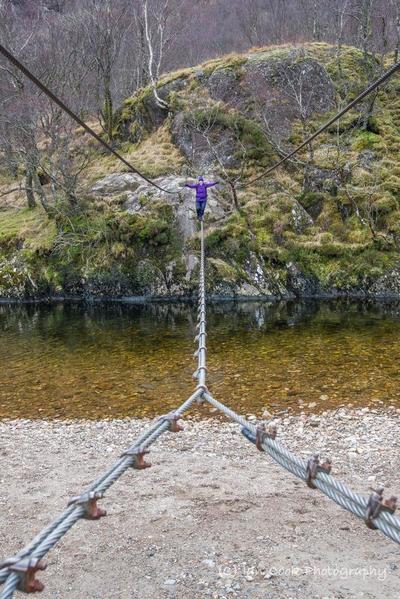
[0,214,400,599]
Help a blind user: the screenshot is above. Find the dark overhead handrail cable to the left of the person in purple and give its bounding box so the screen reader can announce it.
[0,44,176,195]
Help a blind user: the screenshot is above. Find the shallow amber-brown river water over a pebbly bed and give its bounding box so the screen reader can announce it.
[0,301,400,418]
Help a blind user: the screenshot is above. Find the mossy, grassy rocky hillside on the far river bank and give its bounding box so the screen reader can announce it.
[0,44,400,298]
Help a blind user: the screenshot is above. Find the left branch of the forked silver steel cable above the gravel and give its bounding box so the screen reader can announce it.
[0,389,203,599]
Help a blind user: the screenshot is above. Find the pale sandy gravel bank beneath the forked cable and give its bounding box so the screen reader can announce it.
[0,410,400,599]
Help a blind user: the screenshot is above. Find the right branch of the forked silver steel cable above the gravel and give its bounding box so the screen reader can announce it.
[203,392,400,544]
